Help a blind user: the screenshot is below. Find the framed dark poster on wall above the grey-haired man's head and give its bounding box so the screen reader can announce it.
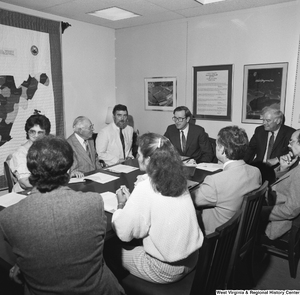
[242,62,288,124]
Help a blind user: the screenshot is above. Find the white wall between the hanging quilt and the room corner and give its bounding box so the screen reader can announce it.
[0,2,116,136]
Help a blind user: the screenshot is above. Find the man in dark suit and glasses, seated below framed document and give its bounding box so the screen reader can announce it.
[164,106,213,163]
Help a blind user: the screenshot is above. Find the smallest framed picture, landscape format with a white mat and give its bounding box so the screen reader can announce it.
[145,77,176,112]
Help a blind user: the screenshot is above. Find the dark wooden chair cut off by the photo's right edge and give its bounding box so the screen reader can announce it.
[261,214,300,279]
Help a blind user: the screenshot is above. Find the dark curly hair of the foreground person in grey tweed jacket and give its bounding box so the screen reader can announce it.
[27,135,73,193]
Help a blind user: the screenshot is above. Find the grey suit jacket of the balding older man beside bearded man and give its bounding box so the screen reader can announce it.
[67,133,101,173]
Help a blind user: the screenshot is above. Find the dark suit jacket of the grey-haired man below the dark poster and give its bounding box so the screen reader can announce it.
[244,125,295,163]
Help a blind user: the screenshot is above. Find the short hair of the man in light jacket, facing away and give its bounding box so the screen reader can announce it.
[216,126,249,160]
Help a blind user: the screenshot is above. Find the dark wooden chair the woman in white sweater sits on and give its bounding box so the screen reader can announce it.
[120,210,241,295]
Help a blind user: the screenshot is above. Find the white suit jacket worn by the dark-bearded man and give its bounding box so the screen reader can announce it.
[96,122,133,166]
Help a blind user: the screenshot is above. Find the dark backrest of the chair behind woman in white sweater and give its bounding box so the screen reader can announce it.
[190,210,242,295]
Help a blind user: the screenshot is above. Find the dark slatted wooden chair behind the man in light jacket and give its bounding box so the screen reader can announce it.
[226,181,268,289]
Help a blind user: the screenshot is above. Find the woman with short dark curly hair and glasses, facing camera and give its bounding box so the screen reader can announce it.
[9,111,51,192]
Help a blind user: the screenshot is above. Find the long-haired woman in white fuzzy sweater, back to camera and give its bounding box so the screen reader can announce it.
[112,133,203,284]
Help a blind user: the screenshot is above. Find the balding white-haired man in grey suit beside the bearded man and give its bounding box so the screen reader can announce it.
[67,116,101,176]
